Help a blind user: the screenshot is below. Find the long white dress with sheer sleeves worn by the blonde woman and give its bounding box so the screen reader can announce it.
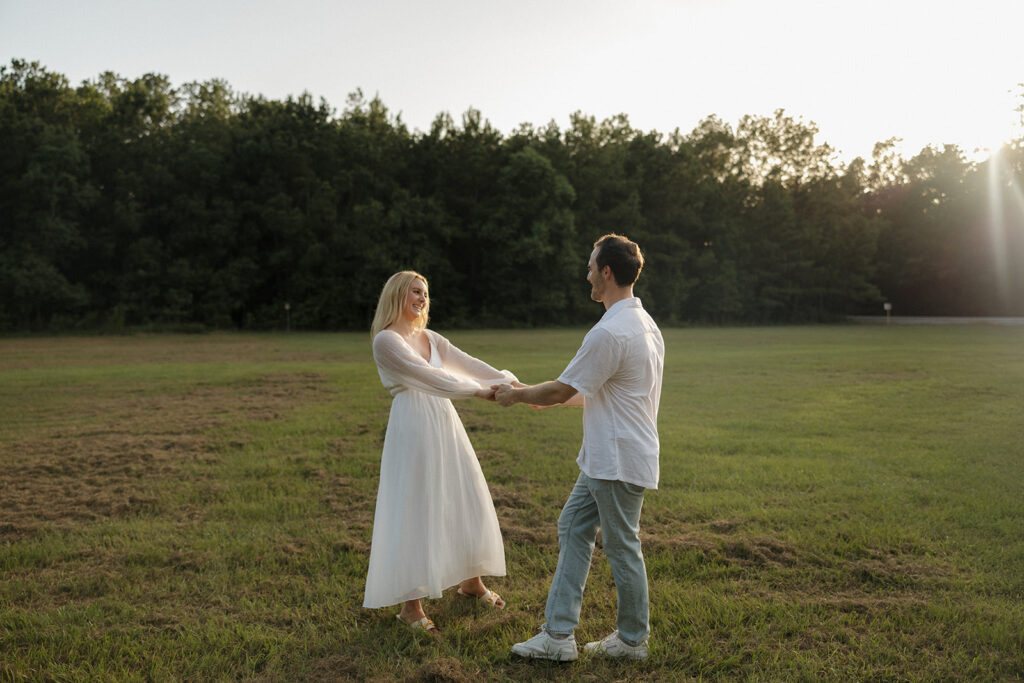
[362,330,515,607]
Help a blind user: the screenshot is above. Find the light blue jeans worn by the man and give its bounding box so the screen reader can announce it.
[544,472,650,645]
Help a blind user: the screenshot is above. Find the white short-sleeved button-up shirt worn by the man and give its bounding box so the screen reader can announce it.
[558,297,665,488]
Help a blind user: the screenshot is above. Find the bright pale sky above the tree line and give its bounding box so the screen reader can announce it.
[6,0,1024,160]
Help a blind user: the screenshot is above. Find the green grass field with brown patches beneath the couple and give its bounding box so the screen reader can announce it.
[0,326,1024,681]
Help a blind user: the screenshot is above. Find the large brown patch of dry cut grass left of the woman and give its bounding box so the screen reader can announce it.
[0,373,328,541]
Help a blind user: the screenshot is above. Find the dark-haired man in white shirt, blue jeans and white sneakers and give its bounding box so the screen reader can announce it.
[495,233,665,661]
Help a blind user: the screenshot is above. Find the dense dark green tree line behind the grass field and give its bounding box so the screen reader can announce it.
[0,59,1024,331]
